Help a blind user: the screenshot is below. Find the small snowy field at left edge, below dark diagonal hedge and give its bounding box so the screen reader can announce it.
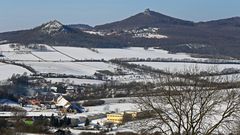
[0,63,31,80]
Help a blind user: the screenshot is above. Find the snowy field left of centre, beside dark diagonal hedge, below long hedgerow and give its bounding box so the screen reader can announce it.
[25,62,114,76]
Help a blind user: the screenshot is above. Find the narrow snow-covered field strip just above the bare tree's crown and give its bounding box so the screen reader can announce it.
[130,62,240,72]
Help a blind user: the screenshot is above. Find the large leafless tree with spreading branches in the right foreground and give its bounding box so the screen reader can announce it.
[137,68,240,135]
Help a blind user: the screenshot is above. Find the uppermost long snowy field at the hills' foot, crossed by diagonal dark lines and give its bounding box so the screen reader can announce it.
[0,44,201,61]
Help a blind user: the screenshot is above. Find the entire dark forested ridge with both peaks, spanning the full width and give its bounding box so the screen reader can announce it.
[0,9,240,58]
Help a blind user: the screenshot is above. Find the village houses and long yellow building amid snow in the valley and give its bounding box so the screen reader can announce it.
[0,96,146,133]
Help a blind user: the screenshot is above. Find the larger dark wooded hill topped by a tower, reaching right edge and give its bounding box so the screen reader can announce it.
[95,9,240,58]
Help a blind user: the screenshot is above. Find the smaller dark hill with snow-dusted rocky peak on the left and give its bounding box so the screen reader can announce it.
[0,20,126,47]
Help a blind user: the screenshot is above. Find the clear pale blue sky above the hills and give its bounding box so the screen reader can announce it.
[0,0,240,32]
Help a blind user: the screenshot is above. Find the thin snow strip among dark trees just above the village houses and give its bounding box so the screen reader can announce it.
[45,78,105,85]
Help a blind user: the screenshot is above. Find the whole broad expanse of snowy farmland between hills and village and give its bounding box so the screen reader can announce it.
[0,44,240,84]
